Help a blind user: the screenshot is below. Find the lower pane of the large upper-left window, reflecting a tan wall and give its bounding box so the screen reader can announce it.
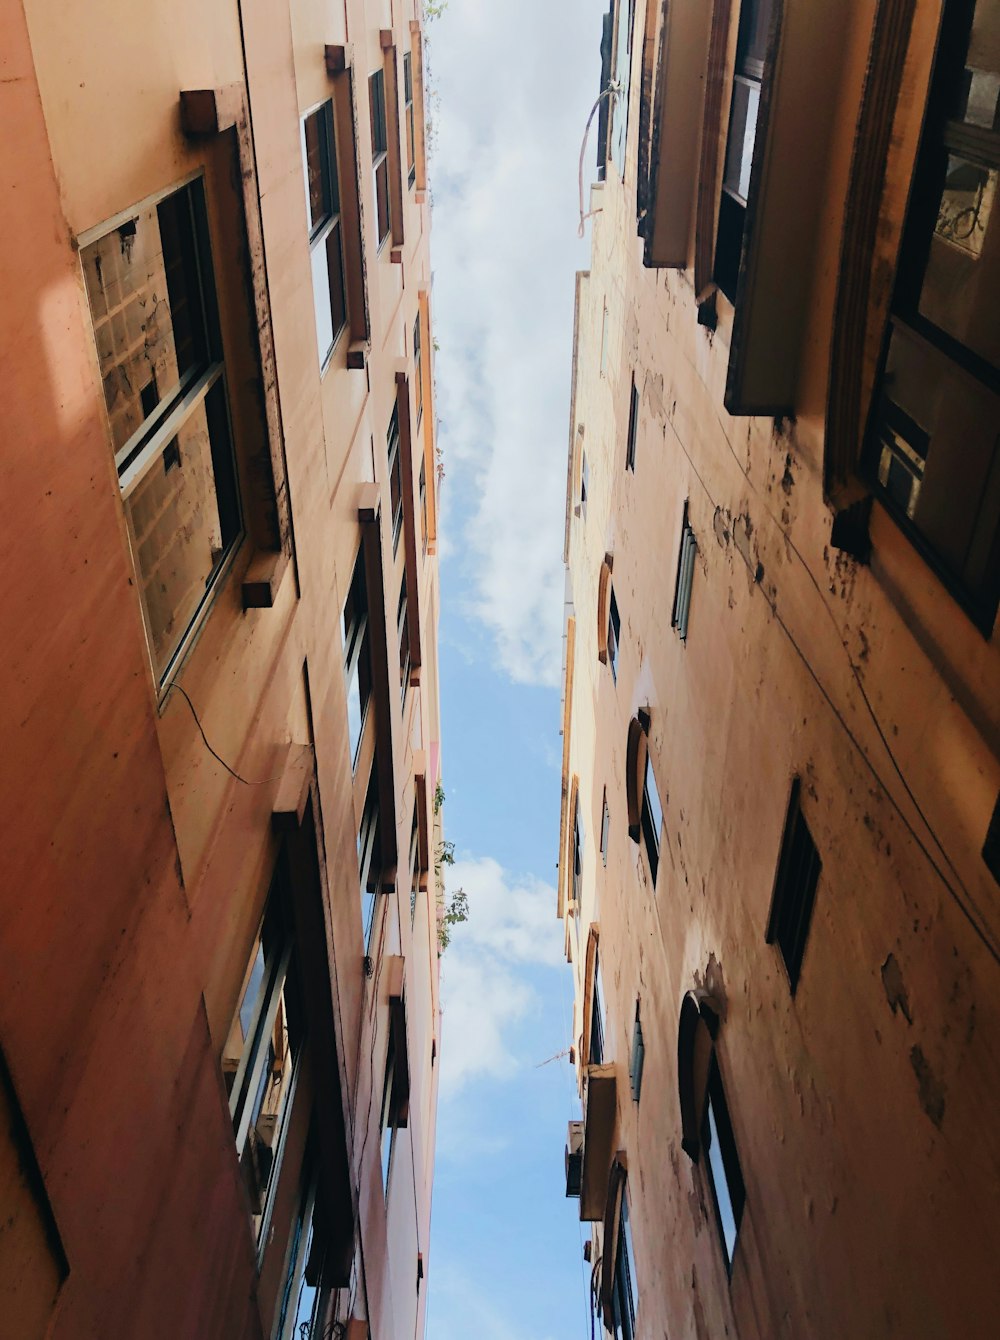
[125,382,235,679]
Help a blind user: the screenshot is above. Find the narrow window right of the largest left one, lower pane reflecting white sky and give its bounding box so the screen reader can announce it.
[302,102,347,367]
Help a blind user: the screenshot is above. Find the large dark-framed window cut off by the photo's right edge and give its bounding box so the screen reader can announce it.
[865,0,1000,632]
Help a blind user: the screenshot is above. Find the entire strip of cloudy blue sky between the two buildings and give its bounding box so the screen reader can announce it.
[426,0,607,1340]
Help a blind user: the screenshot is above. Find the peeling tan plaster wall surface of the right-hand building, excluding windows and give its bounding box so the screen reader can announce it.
[560,7,1000,1340]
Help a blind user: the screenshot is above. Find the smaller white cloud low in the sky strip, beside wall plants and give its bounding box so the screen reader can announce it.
[441,856,563,1095]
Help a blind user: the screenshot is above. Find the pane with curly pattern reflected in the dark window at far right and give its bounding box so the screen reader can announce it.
[918,154,1000,367]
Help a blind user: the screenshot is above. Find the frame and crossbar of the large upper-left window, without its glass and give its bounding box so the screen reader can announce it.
[76,169,248,686]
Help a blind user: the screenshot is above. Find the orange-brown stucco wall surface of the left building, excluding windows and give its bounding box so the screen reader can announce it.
[0,0,440,1340]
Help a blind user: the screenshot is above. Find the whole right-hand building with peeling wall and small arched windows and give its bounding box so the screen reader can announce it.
[559,0,1000,1340]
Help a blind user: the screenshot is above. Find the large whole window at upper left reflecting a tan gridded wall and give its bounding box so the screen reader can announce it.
[80,181,243,683]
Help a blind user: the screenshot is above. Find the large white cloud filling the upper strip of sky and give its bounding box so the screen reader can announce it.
[430,0,607,685]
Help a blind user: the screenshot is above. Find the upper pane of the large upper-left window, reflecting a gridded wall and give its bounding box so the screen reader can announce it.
[80,188,208,452]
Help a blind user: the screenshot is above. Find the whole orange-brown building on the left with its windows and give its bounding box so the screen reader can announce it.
[0,0,440,1340]
